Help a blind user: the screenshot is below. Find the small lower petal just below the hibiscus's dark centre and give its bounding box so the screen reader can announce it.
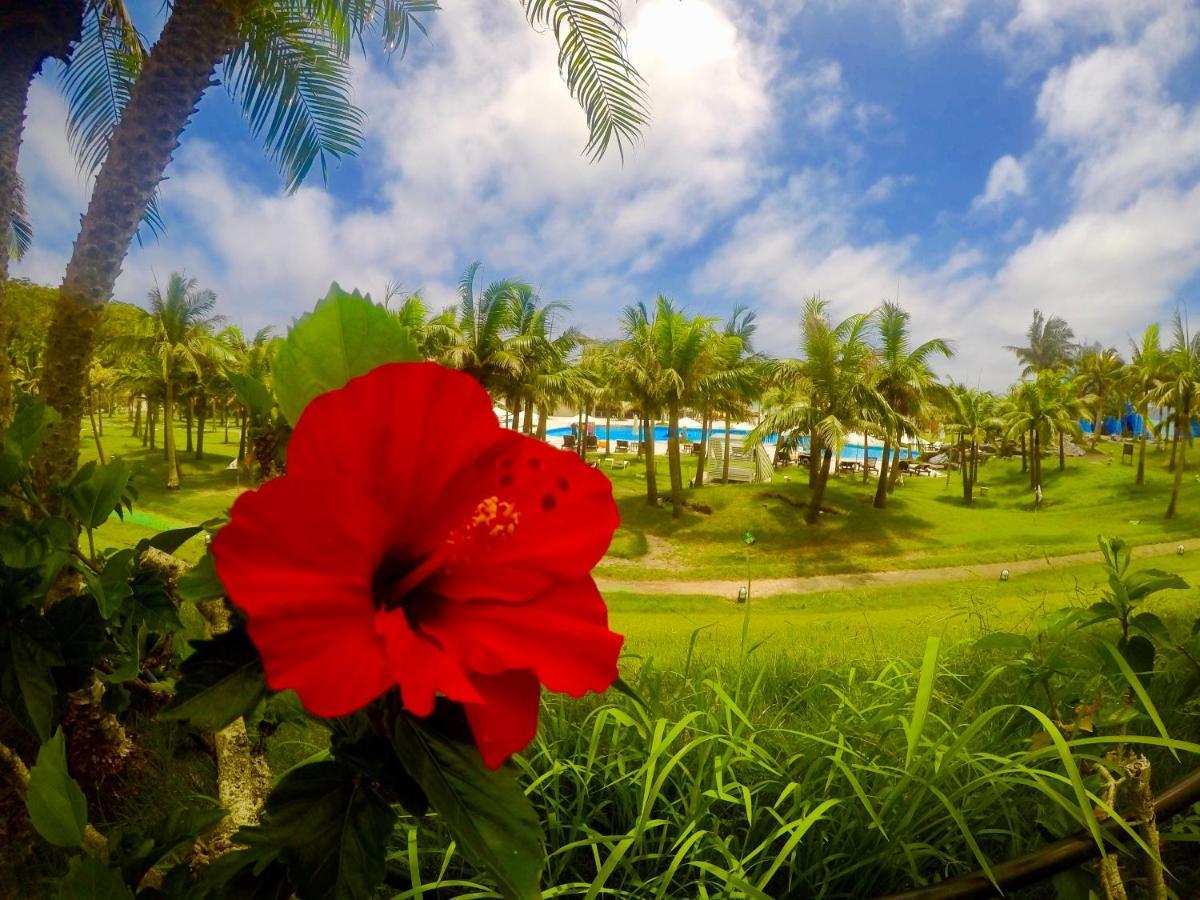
[376,610,481,716]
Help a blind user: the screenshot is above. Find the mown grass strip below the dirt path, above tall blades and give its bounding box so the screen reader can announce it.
[606,550,1200,670]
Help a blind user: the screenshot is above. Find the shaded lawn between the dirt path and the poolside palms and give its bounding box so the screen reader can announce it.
[598,442,1200,581]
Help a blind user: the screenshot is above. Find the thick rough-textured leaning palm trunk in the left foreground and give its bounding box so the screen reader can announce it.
[36,0,240,506]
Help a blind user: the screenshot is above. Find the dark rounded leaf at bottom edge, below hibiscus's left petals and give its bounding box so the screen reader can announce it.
[234,760,396,900]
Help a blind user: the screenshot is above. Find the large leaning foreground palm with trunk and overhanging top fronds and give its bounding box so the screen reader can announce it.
[28,0,647,498]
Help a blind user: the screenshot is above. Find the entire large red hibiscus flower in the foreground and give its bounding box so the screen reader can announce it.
[212,362,622,768]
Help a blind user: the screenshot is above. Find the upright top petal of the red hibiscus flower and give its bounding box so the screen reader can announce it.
[288,362,502,546]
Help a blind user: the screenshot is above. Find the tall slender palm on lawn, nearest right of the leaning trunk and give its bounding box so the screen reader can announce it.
[132,272,222,490]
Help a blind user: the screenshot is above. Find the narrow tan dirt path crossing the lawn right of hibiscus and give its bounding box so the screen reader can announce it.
[596,538,1200,598]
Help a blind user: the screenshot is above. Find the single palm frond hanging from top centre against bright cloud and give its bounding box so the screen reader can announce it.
[524,0,649,160]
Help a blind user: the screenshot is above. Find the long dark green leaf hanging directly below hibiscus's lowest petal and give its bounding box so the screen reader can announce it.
[392,713,546,898]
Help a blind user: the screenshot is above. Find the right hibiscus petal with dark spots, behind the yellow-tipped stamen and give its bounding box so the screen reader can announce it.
[434,432,620,600]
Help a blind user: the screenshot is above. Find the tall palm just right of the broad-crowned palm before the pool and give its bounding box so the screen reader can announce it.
[875,301,954,509]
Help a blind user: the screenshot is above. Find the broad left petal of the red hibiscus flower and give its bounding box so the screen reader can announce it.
[212,474,394,716]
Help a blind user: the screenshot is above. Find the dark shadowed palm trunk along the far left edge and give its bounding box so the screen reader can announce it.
[0,10,83,427]
